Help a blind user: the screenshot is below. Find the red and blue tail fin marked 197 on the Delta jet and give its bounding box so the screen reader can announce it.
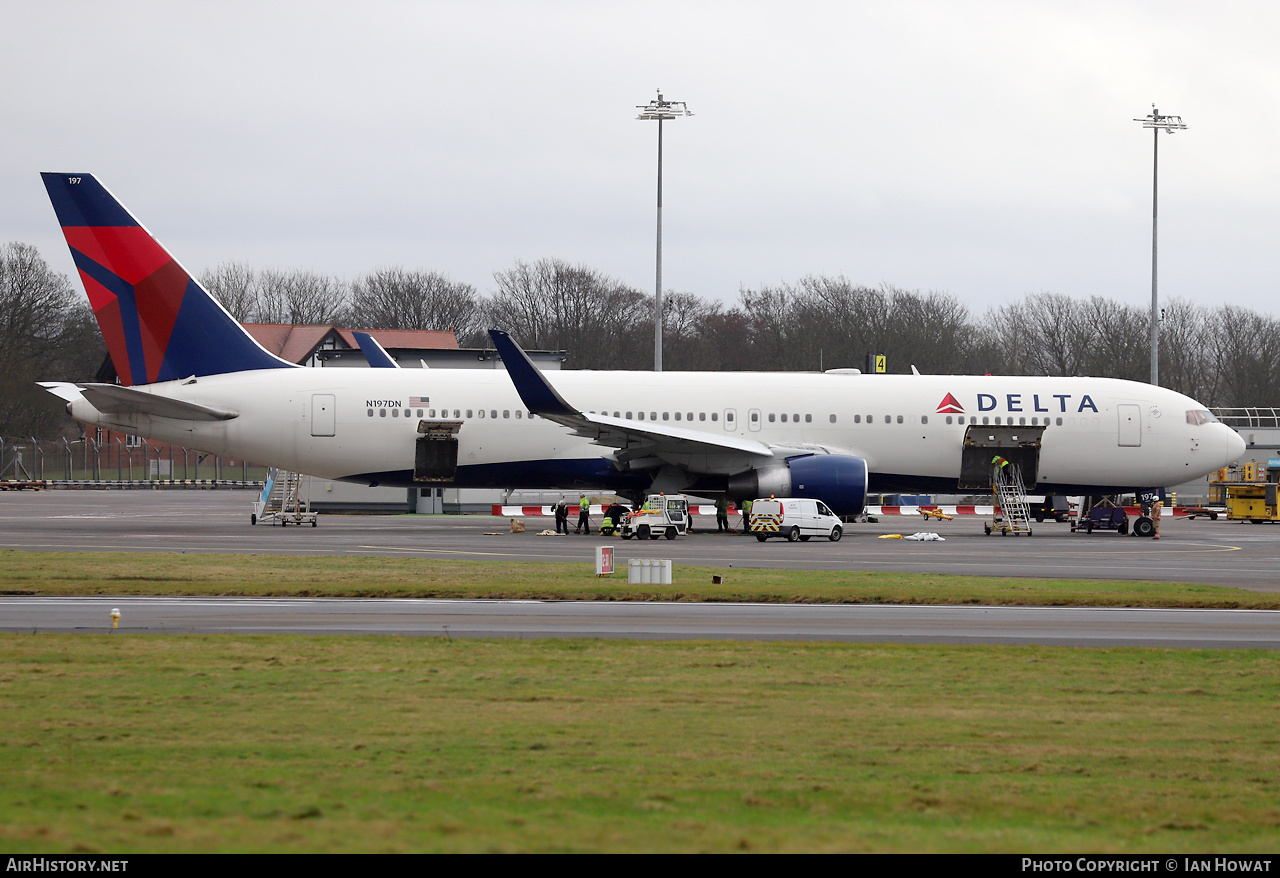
[41,174,294,387]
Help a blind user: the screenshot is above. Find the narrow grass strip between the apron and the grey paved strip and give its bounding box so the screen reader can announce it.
[0,549,1280,609]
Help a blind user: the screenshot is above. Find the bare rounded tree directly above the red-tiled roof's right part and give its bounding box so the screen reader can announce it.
[347,267,480,339]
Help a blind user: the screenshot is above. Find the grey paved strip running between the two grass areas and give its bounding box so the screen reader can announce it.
[0,596,1280,649]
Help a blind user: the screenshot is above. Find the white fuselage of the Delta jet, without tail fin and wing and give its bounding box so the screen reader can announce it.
[64,369,1243,489]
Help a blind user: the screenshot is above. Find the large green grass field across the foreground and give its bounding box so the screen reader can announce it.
[0,635,1280,854]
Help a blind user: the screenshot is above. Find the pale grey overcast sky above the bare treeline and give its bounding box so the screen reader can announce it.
[0,0,1280,314]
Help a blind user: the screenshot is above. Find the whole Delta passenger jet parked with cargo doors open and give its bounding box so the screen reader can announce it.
[42,174,1244,516]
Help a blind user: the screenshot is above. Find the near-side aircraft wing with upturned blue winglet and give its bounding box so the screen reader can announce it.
[489,329,776,457]
